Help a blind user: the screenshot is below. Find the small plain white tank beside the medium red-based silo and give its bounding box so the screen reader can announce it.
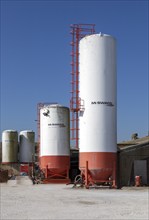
[19,130,35,163]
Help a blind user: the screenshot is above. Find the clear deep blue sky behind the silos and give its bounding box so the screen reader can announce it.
[1,0,149,141]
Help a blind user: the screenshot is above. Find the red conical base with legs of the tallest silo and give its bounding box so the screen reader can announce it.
[79,152,117,187]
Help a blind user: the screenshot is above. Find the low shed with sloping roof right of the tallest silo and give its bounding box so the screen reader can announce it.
[118,136,149,187]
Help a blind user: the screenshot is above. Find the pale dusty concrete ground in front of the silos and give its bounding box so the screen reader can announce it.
[0,180,149,220]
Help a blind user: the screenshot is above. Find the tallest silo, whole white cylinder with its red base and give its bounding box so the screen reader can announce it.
[79,33,117,187]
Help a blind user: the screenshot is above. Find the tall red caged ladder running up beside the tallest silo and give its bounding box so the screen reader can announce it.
[70,24,95,149]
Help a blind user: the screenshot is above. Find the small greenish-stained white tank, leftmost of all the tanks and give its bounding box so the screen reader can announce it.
[2,130,18,163]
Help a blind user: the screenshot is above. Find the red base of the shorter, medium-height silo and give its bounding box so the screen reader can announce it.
[40,156,70,180]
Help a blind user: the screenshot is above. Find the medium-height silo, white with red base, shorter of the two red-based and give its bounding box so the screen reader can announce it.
[40,104,70,178]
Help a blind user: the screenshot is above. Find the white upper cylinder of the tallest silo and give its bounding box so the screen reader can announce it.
[79,34,117,152]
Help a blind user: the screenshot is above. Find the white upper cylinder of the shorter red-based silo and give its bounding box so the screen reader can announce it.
[40,104,70,156]
